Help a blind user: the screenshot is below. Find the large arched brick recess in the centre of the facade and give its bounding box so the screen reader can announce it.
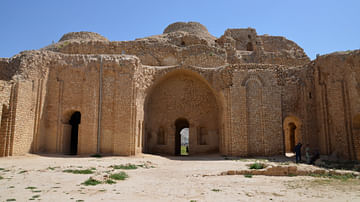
[143,70,221,155]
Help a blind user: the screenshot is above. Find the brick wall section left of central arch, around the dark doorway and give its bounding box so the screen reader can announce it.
[39,54,138,155]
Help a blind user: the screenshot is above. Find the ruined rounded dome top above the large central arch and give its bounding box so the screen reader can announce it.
[164,22,215,38]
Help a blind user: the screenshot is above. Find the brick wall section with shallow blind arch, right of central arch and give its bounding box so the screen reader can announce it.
[229,65,283,156]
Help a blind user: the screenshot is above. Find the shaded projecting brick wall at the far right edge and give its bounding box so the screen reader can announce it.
[313,50,360,159]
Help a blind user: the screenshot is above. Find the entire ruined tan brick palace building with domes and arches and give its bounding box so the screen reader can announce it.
[0,22,360,160]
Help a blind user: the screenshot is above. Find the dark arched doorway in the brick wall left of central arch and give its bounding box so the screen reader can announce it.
[61,110,81,155]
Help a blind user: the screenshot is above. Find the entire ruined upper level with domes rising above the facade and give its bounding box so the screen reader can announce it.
[43,22,310,67]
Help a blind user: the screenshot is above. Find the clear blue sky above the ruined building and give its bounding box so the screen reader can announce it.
[0,0,360,59]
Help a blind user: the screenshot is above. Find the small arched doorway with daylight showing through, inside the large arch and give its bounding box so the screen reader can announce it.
[175,118,189,156]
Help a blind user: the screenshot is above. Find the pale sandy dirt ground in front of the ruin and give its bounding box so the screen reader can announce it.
[0,155,360,202]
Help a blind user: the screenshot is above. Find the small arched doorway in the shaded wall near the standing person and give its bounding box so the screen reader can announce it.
[283,116,302,153]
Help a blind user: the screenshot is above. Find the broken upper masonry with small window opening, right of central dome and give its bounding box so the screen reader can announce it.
[217,28,310,66]
